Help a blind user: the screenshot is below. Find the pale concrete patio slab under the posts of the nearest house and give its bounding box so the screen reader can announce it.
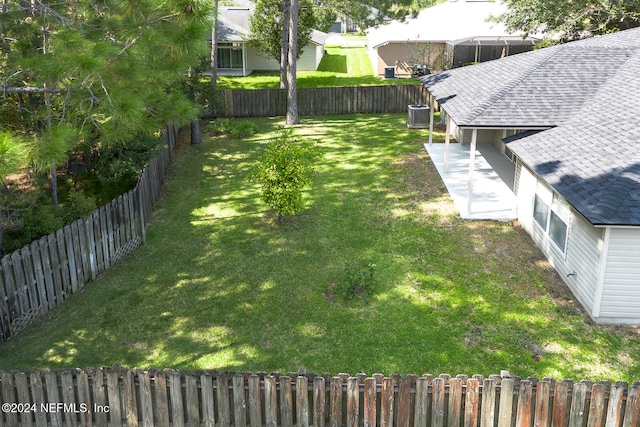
[424,142,516,221]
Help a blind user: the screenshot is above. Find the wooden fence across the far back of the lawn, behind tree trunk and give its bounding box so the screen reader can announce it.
[222,85,427,117]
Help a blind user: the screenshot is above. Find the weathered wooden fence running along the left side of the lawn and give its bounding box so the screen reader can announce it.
[0,127,178,342]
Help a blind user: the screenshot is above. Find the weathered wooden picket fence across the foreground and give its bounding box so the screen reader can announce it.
[0,366,640,427]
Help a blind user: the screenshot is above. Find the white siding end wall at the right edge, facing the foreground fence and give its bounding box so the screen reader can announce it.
[599,227,640,325]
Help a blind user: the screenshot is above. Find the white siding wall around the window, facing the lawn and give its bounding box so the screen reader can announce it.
[514,160,604,315]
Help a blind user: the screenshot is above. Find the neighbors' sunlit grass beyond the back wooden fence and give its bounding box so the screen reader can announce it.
[218,46,420,90]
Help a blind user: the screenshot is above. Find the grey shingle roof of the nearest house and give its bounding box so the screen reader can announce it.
[422,28,640,226]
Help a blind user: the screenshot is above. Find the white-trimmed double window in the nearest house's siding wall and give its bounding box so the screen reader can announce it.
[533,181,571,253]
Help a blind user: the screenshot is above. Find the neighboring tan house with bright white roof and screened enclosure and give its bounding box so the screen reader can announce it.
[367,0,538,77]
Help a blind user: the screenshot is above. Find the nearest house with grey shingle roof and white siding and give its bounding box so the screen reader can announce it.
[421,28,640,325]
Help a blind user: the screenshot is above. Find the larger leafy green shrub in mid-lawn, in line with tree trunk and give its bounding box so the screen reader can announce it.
[249,128,314,222]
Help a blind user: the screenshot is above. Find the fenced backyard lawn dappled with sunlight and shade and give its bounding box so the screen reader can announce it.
[0,114,640,381]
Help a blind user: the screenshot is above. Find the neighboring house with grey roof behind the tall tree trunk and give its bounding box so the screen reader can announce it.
[216,6,327,76]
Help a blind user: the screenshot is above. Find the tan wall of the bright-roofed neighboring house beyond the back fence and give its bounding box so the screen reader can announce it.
[369,42,444,77]
